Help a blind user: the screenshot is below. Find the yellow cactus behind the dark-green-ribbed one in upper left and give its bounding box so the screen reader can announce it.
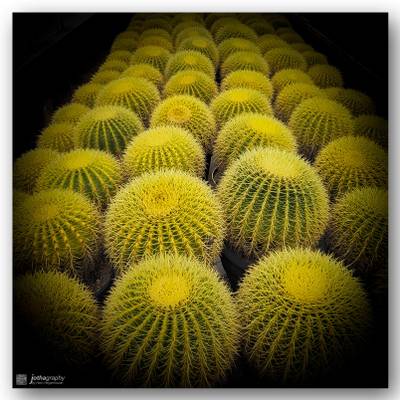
[96,78,160,125]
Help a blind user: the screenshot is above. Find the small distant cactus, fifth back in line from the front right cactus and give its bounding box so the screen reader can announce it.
[221,70,272,99]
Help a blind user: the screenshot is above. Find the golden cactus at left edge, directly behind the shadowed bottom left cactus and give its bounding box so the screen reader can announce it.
[14,189,100,275]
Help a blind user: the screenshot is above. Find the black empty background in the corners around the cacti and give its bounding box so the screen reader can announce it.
[13,13,388,387]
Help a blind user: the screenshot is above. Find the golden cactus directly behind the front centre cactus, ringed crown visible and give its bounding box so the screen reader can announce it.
[105,170,224,273]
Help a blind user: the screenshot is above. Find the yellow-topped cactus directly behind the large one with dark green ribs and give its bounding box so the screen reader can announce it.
[213,113,296,170]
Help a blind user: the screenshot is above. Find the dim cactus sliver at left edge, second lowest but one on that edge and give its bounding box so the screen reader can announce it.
[13,148,59,193]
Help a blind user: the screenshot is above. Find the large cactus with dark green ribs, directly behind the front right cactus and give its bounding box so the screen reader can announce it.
[218,147,328,257]
